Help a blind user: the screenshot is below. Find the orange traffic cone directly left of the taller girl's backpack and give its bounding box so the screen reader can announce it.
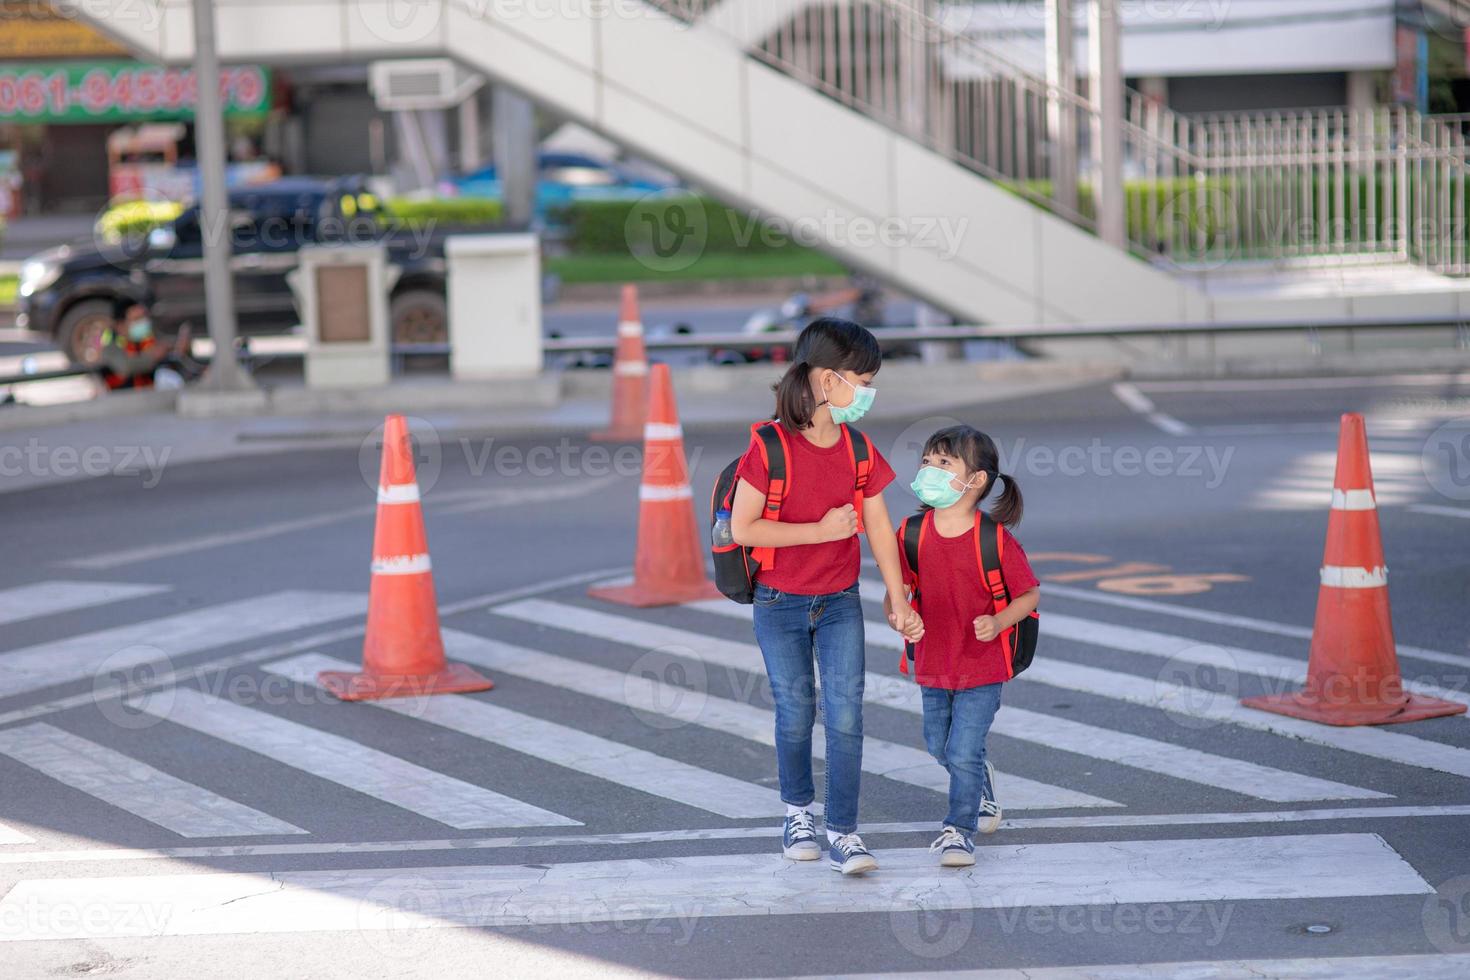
[588,364,720,605]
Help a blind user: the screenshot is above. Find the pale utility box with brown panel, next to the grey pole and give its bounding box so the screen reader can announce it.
[291,245,390,388]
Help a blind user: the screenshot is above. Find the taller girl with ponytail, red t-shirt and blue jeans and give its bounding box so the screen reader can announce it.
[731,317,917,874]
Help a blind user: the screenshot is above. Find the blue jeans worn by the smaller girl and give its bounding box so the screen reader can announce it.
[920,683,1001,833]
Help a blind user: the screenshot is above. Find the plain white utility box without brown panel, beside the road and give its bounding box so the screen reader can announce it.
[444,234,544,379]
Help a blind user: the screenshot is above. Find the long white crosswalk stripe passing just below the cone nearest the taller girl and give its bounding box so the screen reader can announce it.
[494,599,1385,805]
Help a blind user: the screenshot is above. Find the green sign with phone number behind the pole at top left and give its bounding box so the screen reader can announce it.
[0,62,270,123]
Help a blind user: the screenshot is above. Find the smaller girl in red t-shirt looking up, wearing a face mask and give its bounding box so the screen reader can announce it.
[900,425,1041,867]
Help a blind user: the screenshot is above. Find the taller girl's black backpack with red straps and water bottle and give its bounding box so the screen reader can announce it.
[710,420,873,605]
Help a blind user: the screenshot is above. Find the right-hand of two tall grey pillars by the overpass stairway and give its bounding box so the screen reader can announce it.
[1088,0,1127,248]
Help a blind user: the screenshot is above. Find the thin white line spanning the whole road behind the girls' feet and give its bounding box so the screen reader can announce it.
[0,805,1470,864]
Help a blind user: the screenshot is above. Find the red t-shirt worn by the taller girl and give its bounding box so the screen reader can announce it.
[735,429,894,595]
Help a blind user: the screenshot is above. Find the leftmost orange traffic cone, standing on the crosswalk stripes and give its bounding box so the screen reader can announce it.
[318,416,494,701]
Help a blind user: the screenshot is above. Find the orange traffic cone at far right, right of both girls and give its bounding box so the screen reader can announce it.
[1241,413,1466,724]
